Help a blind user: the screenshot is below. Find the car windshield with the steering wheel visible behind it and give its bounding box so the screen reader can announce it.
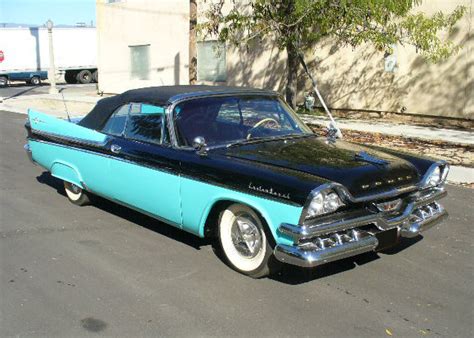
[174,96,312,146]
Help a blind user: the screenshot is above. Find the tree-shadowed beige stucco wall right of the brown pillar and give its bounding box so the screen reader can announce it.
[198,0,474,119]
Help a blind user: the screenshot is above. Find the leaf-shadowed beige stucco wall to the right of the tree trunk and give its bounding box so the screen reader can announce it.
[306,0,474,119]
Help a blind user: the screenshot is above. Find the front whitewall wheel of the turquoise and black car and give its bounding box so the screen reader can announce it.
[218,204,273,278]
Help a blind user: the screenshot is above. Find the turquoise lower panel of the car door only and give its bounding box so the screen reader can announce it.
[109,159,181,225]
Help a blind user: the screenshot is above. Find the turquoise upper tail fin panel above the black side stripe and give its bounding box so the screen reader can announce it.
[28,109,107,142]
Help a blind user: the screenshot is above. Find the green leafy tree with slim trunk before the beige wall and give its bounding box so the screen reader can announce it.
[199,0,466,107]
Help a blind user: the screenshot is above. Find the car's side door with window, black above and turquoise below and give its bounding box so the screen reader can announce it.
[104,103,181,226]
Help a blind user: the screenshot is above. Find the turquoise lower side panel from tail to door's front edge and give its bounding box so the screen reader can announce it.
[29,141,181,226]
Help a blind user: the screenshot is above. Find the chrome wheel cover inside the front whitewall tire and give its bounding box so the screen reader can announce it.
[231,214,262,259]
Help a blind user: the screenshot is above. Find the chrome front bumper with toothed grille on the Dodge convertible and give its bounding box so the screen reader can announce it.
[274,188,448,267]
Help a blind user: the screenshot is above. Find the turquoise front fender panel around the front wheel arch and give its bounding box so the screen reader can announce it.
[181,178,303,245]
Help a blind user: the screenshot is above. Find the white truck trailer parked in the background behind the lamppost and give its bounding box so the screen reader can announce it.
[0,27,97,86]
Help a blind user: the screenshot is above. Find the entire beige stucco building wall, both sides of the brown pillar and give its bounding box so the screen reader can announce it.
[97,0,474,119]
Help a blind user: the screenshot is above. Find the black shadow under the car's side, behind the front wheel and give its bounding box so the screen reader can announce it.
[36,171,212,250]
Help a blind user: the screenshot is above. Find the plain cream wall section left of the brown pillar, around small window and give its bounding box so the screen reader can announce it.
[97,0,189,93]
